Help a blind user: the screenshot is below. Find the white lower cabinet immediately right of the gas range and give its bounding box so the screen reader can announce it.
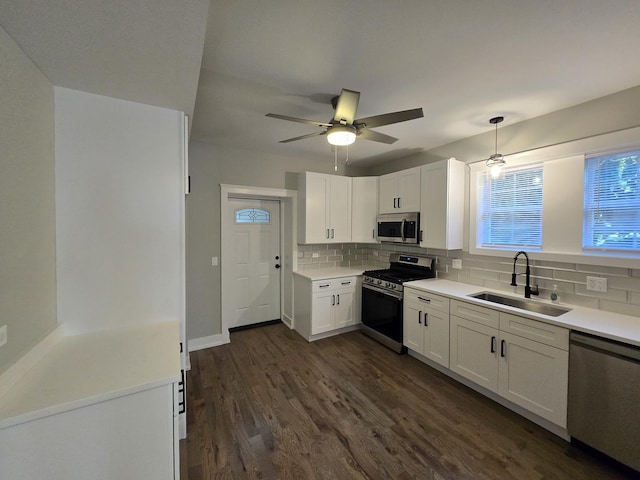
[403,288,449,367]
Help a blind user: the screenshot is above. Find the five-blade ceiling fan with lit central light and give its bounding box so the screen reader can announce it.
[266,89,424,146]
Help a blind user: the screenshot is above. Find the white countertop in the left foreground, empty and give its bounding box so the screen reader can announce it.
[0,322,180,428]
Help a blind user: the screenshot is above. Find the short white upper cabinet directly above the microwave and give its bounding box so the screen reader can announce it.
[378,167,420,213]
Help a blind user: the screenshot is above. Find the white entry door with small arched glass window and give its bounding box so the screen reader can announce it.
[226,198,281,328]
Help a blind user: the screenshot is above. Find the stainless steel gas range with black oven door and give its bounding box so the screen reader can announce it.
[362,253,435,353]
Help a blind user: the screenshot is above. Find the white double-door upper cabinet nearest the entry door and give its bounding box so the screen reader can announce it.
[298,172,351,243]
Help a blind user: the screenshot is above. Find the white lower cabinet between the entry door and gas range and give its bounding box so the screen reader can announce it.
[294,275,360,341]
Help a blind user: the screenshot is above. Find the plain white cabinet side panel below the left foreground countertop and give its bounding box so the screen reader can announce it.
[0,384,180,480]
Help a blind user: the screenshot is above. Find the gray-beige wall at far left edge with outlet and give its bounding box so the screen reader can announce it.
[0,27,56,373]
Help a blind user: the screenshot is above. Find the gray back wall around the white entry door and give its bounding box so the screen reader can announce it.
[187,142,350,339]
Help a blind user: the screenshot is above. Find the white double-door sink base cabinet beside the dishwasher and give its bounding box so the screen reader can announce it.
[450,300,569,428]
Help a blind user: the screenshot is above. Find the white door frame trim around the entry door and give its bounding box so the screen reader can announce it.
[220,184,298,343]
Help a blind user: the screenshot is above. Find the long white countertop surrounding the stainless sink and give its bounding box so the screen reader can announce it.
[404,278,640,346]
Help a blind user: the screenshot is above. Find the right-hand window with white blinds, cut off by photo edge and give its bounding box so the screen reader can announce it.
[582,149,640,251]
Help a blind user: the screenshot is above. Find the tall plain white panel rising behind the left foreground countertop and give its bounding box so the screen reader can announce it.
[55,87,184,334]
